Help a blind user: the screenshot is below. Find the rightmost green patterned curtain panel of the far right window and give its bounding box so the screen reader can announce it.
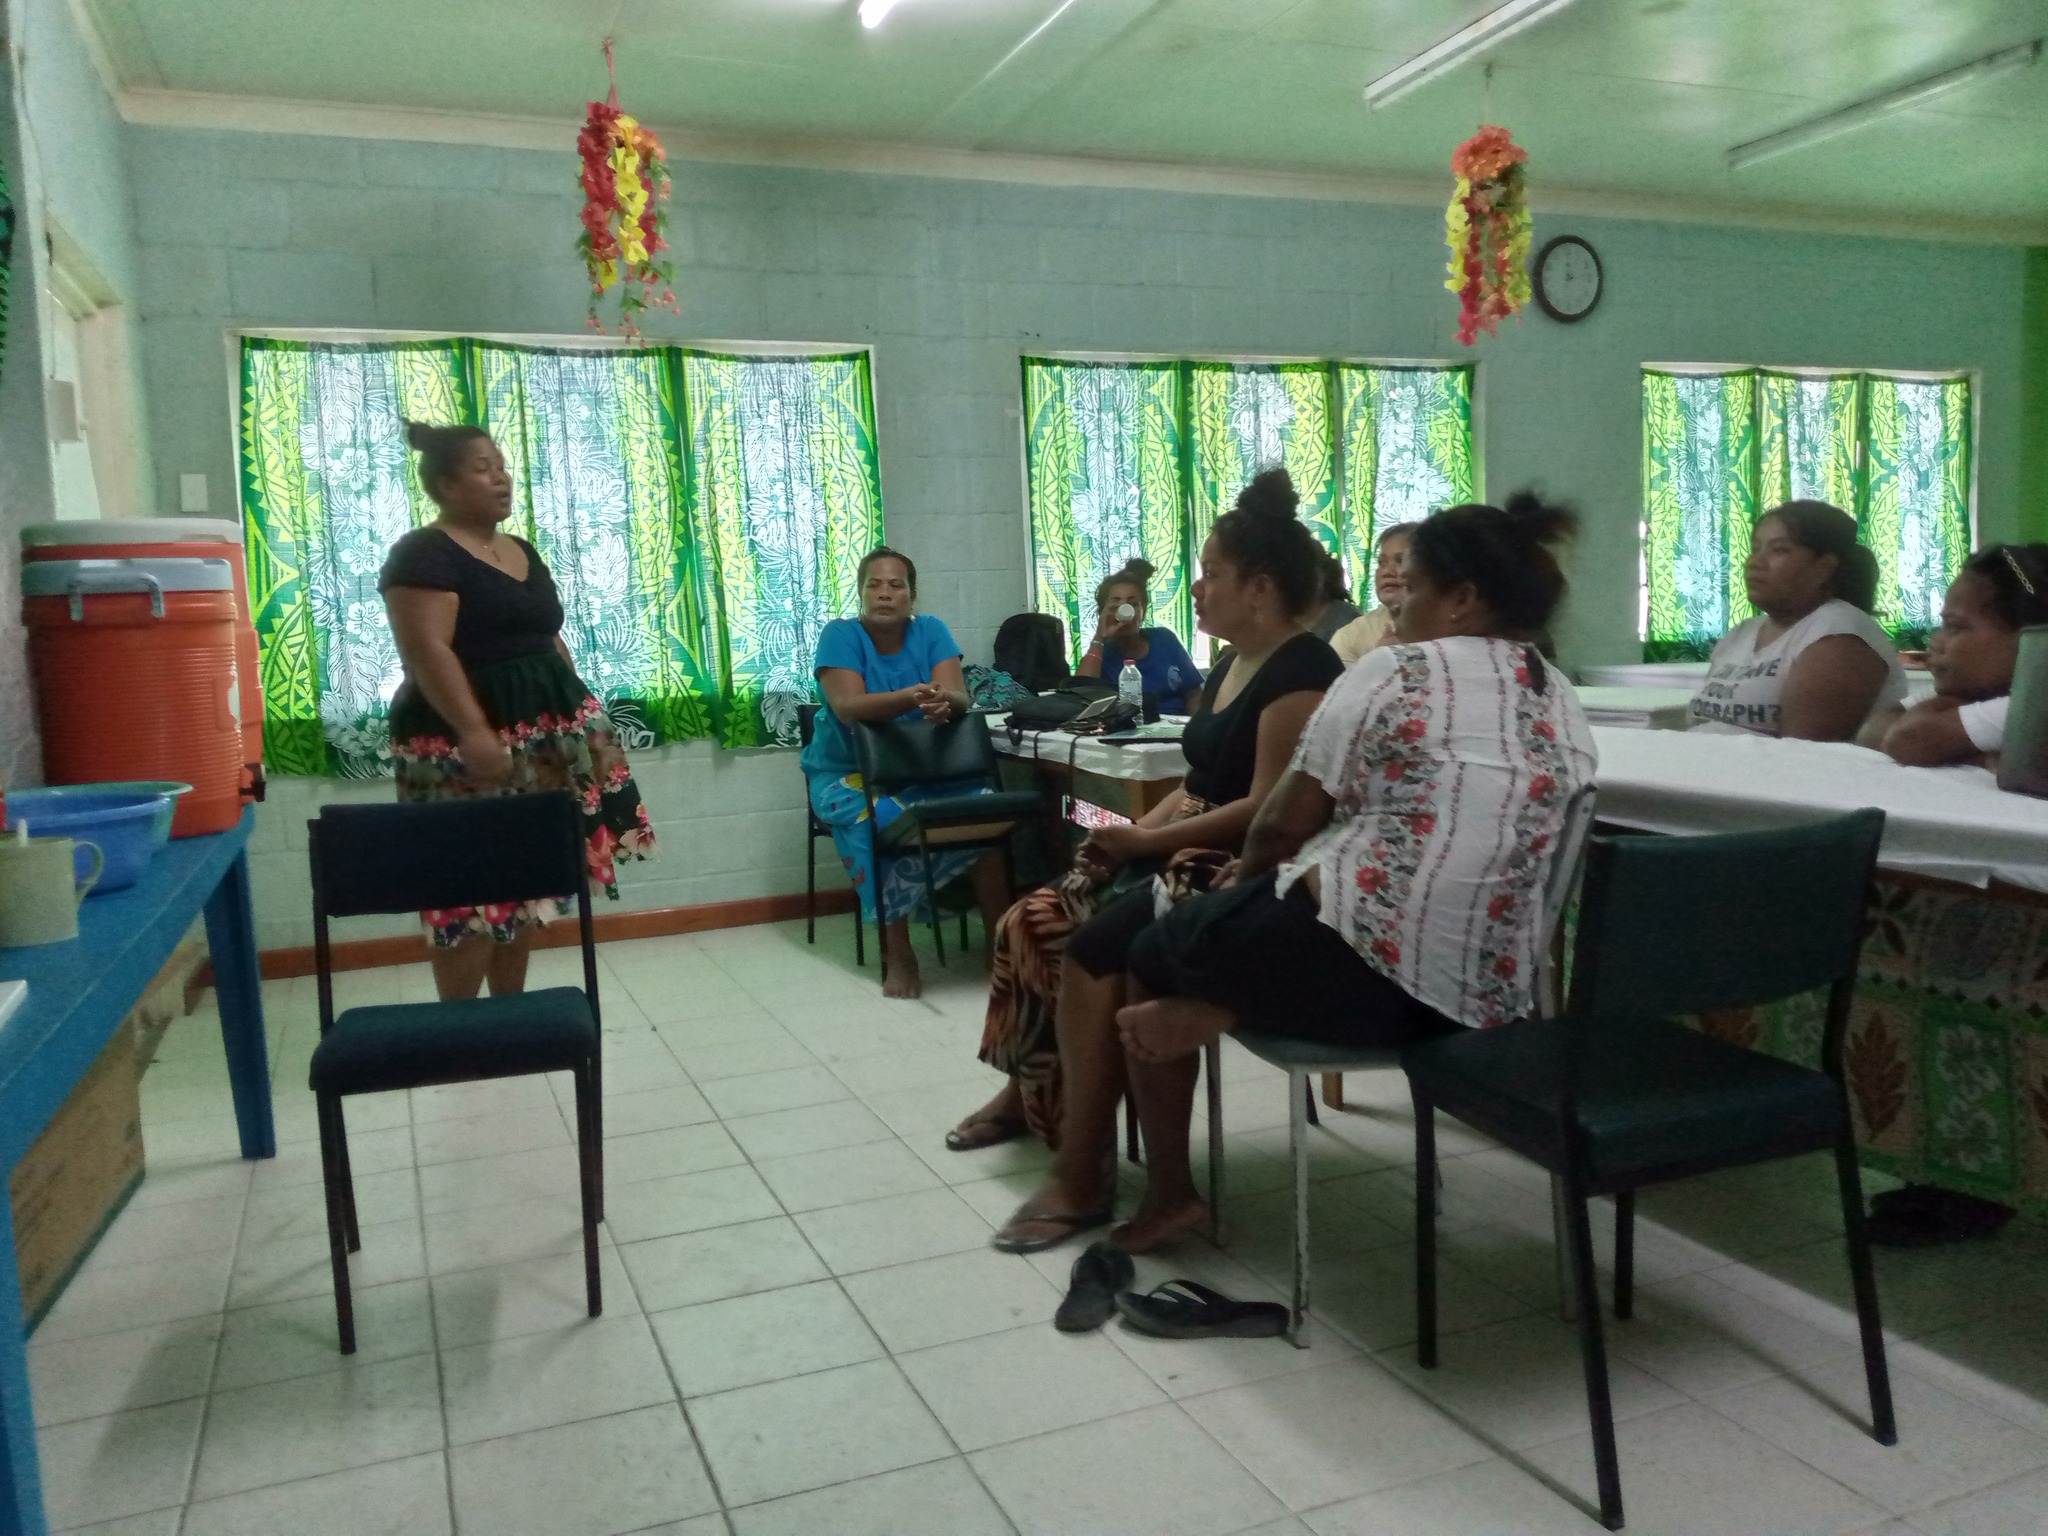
[1858,375,1970,649]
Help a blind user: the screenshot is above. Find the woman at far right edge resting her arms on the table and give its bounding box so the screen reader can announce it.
[1855,545,2048,768]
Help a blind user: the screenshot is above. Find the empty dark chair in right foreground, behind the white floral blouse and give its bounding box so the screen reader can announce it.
[1401,811,1898,1530]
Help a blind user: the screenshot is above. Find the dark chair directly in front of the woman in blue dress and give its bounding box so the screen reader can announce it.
[852,715,1038,969]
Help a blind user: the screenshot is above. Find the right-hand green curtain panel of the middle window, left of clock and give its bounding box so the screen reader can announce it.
[1337,362,1473,592]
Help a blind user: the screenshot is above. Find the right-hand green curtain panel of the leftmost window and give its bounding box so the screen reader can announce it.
[678,352,883,748]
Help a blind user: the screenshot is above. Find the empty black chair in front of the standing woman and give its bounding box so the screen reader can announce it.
[307,795,604,1354]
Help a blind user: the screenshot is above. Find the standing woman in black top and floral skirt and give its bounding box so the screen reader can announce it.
[377,422,653,1001]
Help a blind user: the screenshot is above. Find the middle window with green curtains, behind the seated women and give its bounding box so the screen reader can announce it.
[1024,356,1473,671]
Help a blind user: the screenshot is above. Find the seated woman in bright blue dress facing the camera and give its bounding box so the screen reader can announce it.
[803,547,1010,997]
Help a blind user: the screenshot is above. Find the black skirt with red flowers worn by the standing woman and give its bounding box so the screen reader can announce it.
[391,651,653,948]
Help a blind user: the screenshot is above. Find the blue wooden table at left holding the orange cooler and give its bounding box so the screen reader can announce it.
[0,809,276,1536]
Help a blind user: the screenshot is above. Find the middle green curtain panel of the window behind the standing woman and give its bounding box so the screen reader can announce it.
[469,342,717,748]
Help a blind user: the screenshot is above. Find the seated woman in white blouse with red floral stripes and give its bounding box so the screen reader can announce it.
[1112,496,1595,1251]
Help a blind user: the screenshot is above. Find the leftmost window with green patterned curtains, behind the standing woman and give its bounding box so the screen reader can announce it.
[242,336,881,776]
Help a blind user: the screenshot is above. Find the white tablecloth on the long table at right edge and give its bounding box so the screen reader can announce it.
[1593,727,2048,891]
